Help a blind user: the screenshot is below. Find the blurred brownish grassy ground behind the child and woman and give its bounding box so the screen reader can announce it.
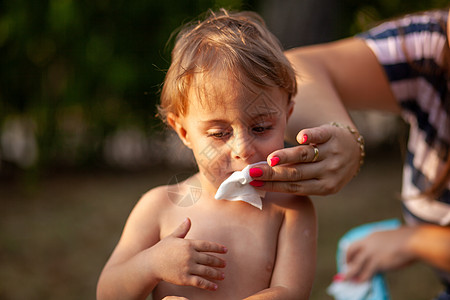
[0,148,440,300]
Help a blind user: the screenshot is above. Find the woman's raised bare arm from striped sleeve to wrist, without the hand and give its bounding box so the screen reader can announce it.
[286,38,399,140]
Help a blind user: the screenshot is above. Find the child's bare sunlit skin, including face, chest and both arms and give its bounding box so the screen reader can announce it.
[99,75,316,299]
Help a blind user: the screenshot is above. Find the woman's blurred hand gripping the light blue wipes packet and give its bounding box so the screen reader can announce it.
[345,226,416,281]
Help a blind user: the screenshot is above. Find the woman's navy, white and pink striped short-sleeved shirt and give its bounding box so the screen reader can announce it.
[358,11,450,226]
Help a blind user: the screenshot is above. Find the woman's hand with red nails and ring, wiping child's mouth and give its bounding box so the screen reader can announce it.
[250,125,361,195]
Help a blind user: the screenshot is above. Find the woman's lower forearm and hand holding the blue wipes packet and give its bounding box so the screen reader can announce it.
[345,11,450,281]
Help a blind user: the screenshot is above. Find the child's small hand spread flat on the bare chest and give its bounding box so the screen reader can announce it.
[152,218,227,291]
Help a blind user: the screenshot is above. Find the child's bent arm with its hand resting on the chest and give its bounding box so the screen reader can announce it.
[97,189,226,300]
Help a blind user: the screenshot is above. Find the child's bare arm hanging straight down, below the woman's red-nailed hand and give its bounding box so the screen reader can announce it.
[243,197,317,300]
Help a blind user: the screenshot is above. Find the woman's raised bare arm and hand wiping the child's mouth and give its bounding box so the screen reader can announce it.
[255,8,450,195]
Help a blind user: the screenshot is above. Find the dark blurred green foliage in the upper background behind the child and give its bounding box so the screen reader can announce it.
[0,0,448,172]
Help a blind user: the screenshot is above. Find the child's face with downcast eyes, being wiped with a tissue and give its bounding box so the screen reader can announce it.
[171,79,293,187]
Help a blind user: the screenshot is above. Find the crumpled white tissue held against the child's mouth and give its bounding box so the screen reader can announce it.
[214,161,267,210]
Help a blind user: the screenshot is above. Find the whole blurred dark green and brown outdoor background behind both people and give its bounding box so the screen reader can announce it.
[0,0,448,300]
